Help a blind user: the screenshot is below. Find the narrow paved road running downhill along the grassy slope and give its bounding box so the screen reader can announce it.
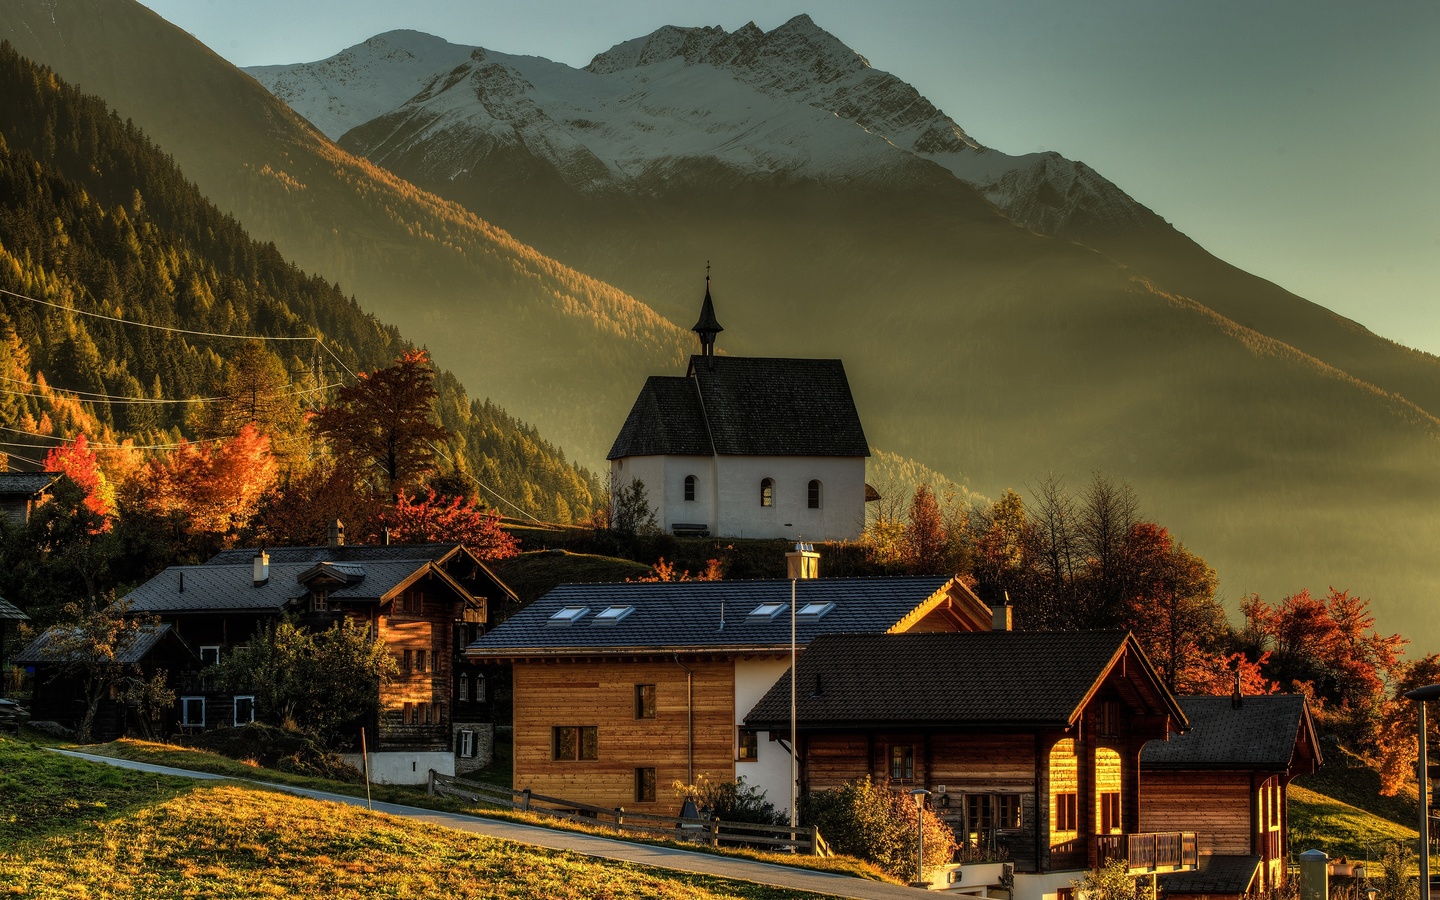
[55,750,927,900]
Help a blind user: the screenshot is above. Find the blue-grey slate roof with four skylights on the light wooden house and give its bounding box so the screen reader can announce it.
[467,576,952,657]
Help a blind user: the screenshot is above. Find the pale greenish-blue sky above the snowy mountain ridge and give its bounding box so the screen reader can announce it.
[141,0,1440,354]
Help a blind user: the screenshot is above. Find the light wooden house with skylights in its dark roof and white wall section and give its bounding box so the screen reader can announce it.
[467,577,992,811]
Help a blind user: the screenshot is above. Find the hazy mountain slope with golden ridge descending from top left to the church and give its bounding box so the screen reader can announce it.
[0,0,688,459]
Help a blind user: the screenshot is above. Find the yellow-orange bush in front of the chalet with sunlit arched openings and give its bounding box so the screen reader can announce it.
[802,776,956,880]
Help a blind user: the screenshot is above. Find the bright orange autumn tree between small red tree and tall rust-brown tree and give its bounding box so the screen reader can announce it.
[138,425,276,534]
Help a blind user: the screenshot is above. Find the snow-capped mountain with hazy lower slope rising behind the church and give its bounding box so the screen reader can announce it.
[244,17,1440,642]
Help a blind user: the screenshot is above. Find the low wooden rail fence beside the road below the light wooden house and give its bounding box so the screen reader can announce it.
[429,769,834,857]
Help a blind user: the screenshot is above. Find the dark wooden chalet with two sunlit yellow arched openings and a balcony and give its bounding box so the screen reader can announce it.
[744,631,1197,897]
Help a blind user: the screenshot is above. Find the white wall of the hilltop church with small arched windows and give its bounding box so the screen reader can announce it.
[611,456,865,540]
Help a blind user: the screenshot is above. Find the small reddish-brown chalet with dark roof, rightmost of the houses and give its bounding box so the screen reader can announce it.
[1140,693,1320,897]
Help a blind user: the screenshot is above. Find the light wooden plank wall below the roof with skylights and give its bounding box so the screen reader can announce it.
[513,658,736,812]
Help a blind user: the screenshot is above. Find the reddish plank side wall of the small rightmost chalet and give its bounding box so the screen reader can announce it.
[1140,772,1253,855]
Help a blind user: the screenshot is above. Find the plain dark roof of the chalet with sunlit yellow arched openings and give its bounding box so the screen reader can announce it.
[744,631,1146,727]
